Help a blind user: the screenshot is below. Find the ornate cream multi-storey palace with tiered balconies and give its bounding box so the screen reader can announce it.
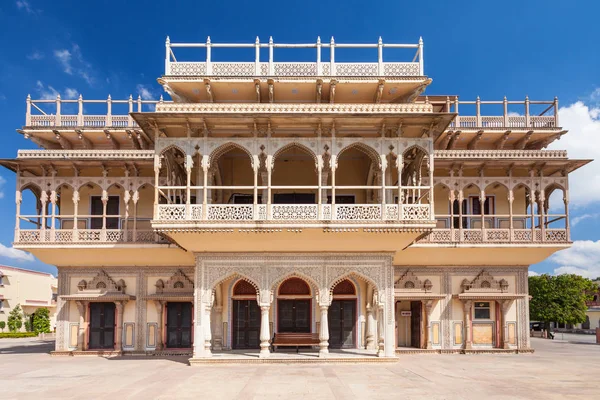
[1,38,589,363]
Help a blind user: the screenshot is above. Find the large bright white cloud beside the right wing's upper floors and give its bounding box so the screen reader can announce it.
[548,101,600,207]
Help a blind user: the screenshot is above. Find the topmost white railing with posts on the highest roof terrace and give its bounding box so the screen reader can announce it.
[165,37,424,78]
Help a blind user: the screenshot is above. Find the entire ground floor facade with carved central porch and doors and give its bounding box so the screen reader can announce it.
[51,253,530,360]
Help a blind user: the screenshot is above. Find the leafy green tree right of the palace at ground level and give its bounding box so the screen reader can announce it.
[529,274,597,331]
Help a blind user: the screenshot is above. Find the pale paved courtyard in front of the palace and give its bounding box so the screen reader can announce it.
[0,335,600,400]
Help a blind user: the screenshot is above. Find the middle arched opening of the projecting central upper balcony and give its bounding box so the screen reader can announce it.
[271,143,318,204]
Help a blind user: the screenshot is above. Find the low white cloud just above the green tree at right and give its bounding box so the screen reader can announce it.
[548,240,600,278]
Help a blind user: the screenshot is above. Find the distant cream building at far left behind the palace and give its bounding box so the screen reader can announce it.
[0,265,57,332]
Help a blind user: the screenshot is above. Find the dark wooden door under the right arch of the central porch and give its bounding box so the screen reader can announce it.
[327,300,356,349]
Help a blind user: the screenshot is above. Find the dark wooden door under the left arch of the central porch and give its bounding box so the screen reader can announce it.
[232,300,260,349]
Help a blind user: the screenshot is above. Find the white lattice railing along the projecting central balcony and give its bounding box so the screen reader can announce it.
[155,204,432,223]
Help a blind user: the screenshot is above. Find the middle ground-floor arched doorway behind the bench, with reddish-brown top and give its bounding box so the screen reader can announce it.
[277,277,312,333]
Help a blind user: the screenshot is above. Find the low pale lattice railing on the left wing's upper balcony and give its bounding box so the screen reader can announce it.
[15,229,166,244]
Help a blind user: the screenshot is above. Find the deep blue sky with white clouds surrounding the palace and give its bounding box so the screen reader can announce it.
[0,0,600,276]
